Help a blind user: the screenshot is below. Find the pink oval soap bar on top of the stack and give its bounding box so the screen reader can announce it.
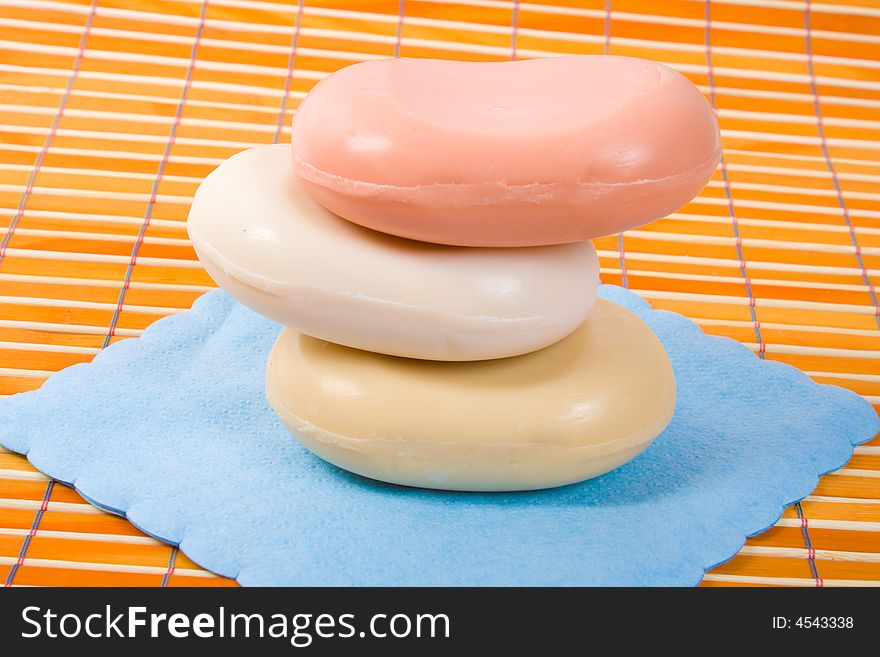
[292,55,721,246]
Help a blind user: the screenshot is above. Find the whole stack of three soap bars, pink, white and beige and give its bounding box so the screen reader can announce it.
[187,56,721,491]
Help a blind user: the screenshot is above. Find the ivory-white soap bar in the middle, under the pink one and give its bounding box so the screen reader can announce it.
[187,146,599,360]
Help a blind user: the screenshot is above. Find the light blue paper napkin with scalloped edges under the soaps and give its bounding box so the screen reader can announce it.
[0,285,878,585]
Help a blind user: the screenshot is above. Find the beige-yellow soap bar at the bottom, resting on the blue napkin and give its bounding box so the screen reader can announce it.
[266,299,675,491]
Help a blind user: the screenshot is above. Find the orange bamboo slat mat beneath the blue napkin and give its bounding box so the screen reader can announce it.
[0,0,880,586]
